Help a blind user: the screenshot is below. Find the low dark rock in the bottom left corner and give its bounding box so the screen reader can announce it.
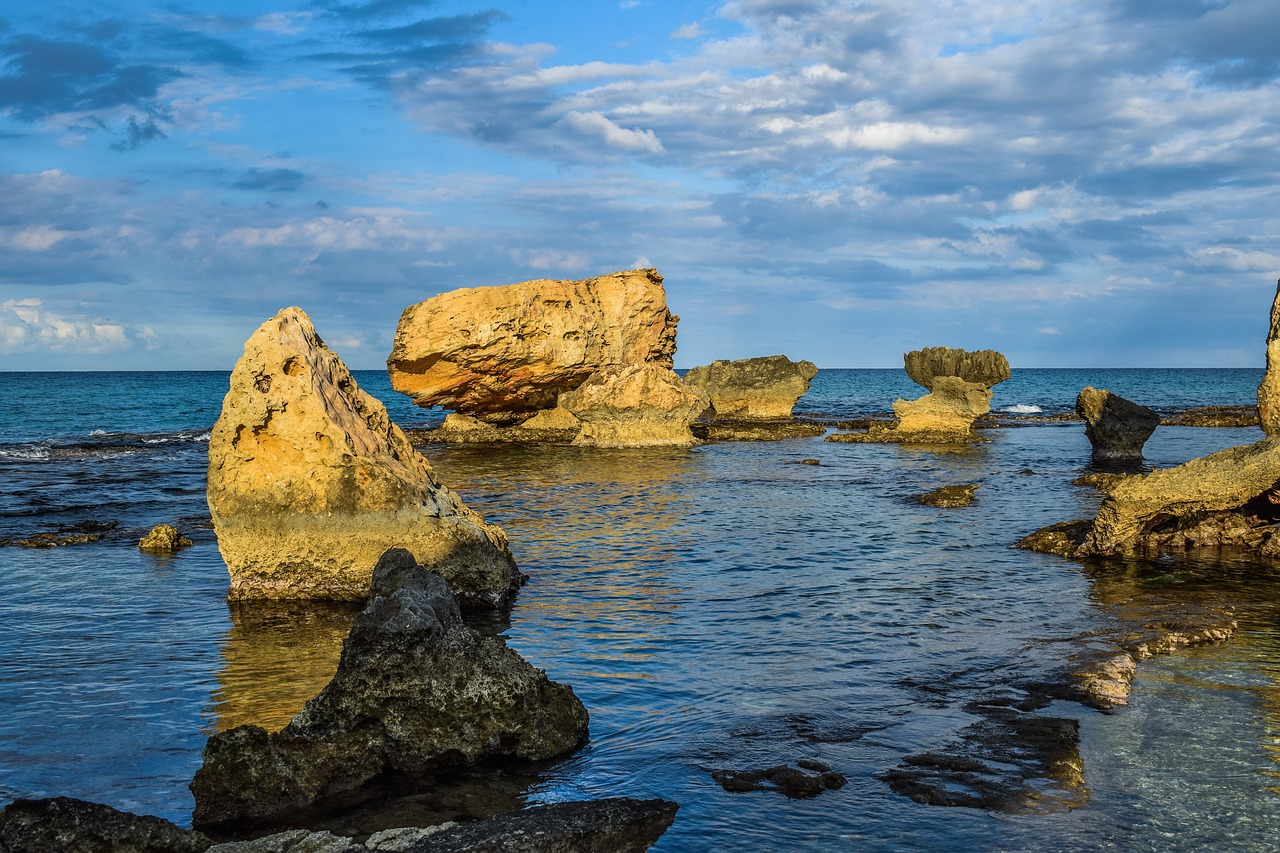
[0,797,211,853]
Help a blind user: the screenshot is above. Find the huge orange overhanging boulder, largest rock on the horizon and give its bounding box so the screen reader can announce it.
[387,269,680,424]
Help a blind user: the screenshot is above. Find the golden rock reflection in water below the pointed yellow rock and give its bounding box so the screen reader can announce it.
[209,601,360,731]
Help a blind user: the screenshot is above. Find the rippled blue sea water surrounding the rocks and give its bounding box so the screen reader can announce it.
[0,369,1280,850]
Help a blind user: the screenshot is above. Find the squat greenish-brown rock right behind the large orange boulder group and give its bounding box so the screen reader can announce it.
[685,356,818,420]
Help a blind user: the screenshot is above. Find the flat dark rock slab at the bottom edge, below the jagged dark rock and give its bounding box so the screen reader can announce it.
[406,797,678,853]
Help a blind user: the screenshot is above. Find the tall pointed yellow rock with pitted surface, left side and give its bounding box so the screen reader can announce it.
[207,307,518,607]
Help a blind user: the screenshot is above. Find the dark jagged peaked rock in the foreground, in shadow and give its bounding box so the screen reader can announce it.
[191,548,588,827]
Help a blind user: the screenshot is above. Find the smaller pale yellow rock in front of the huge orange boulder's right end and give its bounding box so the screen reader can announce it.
[559,364,708,447]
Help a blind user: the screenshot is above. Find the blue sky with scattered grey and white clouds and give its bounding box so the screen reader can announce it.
[0,0,1280,370]
